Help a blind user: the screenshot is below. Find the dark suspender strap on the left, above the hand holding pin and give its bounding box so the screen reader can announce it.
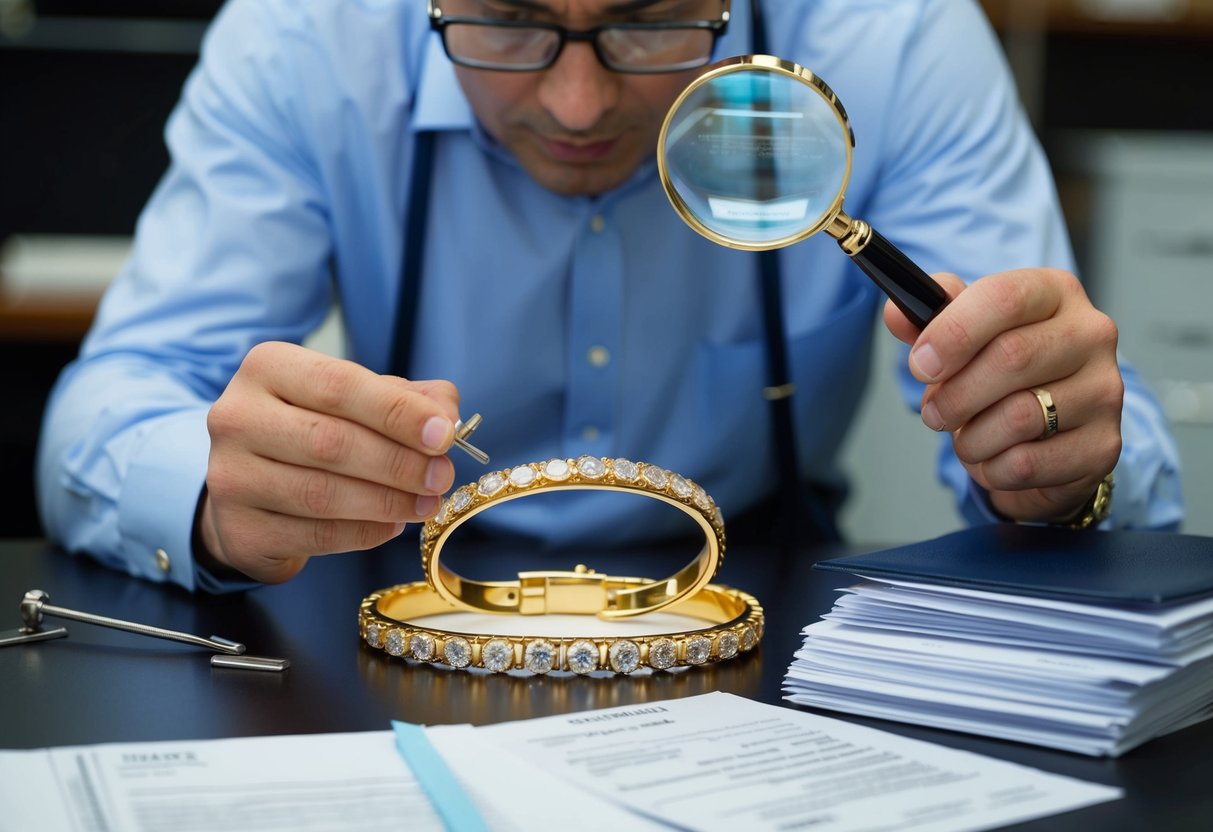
[392,130,434,378]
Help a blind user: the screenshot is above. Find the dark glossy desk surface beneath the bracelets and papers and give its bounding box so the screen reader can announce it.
[0,541,1213,831]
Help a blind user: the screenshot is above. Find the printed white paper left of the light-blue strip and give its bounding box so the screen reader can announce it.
[0,730,444,832]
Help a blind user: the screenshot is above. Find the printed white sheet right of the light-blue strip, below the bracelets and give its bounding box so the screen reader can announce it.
[426,693,1121,832]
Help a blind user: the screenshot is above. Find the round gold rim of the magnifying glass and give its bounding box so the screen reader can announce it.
[657,55,855,251]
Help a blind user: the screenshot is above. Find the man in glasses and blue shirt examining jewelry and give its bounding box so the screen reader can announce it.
[39,0,1181,591]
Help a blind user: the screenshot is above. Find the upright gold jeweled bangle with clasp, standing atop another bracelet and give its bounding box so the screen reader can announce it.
[421,456,724,619]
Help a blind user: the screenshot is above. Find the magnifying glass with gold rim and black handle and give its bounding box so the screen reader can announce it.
[657,55,949,329]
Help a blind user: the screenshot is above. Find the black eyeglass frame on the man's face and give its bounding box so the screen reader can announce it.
[429,7,729,75]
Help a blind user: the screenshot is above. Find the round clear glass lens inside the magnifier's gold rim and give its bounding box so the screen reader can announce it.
[662,70,850,247]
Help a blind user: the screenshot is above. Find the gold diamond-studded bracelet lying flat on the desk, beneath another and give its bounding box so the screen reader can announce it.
[358,576,764,676]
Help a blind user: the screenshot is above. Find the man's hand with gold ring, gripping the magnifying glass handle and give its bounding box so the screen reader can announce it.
[884,269,1124,522]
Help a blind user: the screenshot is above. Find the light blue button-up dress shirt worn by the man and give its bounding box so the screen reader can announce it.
[39,0,1181,589]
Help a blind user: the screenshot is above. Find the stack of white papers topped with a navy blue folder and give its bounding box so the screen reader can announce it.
[784,526,1213,756]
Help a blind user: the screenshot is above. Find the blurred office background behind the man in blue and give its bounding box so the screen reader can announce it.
[0,0,1213,543]
